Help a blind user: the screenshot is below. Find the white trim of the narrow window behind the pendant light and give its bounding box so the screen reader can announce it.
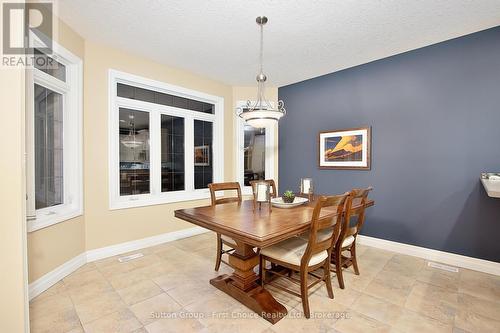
[234,101,278,195]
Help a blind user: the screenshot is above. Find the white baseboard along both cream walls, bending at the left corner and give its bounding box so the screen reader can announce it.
[28,227,209,300]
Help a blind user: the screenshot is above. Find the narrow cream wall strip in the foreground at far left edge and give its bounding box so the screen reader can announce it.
[0,40,27,332]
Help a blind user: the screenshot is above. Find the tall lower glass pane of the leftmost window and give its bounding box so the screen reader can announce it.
[34,84,64,209]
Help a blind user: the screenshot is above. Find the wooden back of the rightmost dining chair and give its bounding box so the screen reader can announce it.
[338,186,373,245]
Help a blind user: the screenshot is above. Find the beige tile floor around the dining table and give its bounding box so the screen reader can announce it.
[30,234,500,333]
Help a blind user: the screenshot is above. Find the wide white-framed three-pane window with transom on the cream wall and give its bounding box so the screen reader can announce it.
[109,70,224,209]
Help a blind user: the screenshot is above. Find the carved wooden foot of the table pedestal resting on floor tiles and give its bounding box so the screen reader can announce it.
[210,274,287,324]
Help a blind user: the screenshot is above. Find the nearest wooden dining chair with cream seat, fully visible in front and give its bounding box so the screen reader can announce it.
[259,193,349,318]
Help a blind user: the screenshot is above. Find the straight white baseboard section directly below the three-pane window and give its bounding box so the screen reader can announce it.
[87,227,209,262]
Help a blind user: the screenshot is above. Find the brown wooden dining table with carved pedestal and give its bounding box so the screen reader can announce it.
[175,195,374,324]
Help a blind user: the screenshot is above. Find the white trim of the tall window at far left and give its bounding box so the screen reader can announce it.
[26,41,83,232]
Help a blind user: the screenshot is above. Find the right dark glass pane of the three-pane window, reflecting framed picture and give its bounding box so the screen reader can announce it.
[194,120,213,189]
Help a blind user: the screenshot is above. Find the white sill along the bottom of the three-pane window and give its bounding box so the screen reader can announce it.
[109,189,210,210]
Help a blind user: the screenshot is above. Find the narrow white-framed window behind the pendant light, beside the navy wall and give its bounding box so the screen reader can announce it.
[235,101,275,194]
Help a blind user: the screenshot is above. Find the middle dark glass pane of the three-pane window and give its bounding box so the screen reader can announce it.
[161,114,184,192]
